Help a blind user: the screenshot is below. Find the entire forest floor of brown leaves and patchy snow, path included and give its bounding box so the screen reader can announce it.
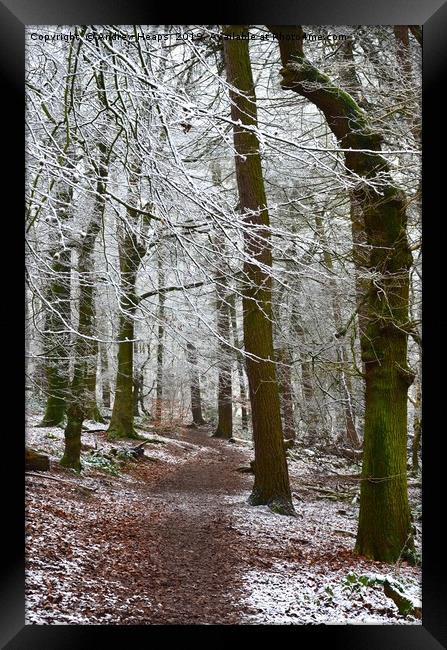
[26,414,421,625]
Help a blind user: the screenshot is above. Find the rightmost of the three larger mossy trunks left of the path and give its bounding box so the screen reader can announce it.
[107,162,146,440]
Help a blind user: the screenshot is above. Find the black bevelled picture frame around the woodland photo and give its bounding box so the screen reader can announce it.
[4,0,447,650]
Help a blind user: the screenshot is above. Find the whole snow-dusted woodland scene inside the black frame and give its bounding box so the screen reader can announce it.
[26,25,422,625]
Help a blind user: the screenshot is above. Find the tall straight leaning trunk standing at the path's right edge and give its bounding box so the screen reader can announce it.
[224,25,294,514]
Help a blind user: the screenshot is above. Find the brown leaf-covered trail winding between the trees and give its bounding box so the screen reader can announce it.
[122,427,254,624]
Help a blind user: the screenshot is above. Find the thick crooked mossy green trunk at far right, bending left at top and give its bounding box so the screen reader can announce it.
[271,26,413,562]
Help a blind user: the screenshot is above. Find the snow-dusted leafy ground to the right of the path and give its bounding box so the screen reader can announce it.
[226,450,422,625]
